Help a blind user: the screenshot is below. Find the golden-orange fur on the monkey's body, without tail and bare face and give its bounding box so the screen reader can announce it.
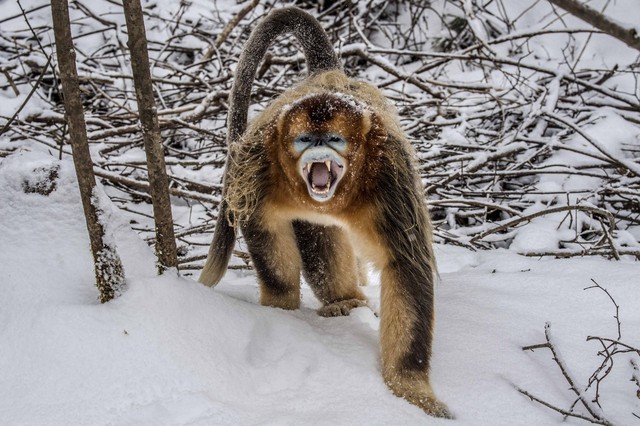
[220,70,449,417]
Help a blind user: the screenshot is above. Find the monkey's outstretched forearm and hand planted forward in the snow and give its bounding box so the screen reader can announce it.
[380,257,452,418]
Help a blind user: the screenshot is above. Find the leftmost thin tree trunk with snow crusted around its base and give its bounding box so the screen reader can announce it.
[51,0,125,303]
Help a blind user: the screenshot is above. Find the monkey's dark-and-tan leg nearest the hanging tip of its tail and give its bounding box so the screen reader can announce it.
[242,216,302,309]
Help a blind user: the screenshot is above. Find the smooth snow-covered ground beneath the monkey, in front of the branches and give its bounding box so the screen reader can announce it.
[0,149,640,425]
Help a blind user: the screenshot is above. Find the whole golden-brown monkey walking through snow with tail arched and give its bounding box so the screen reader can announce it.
[200,8,451,417]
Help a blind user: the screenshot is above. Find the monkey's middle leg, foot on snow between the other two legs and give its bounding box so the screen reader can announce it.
[293,220,367,317]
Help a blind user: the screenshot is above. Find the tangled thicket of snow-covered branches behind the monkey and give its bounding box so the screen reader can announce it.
[0,0,640,274]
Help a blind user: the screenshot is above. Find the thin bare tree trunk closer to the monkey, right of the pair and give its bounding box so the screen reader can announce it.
[123,0,178,273]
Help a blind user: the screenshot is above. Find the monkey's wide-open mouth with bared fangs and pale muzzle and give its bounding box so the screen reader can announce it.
[300,155,345,202]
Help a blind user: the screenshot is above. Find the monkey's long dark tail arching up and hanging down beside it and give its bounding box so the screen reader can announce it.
[199,7,342,286]
